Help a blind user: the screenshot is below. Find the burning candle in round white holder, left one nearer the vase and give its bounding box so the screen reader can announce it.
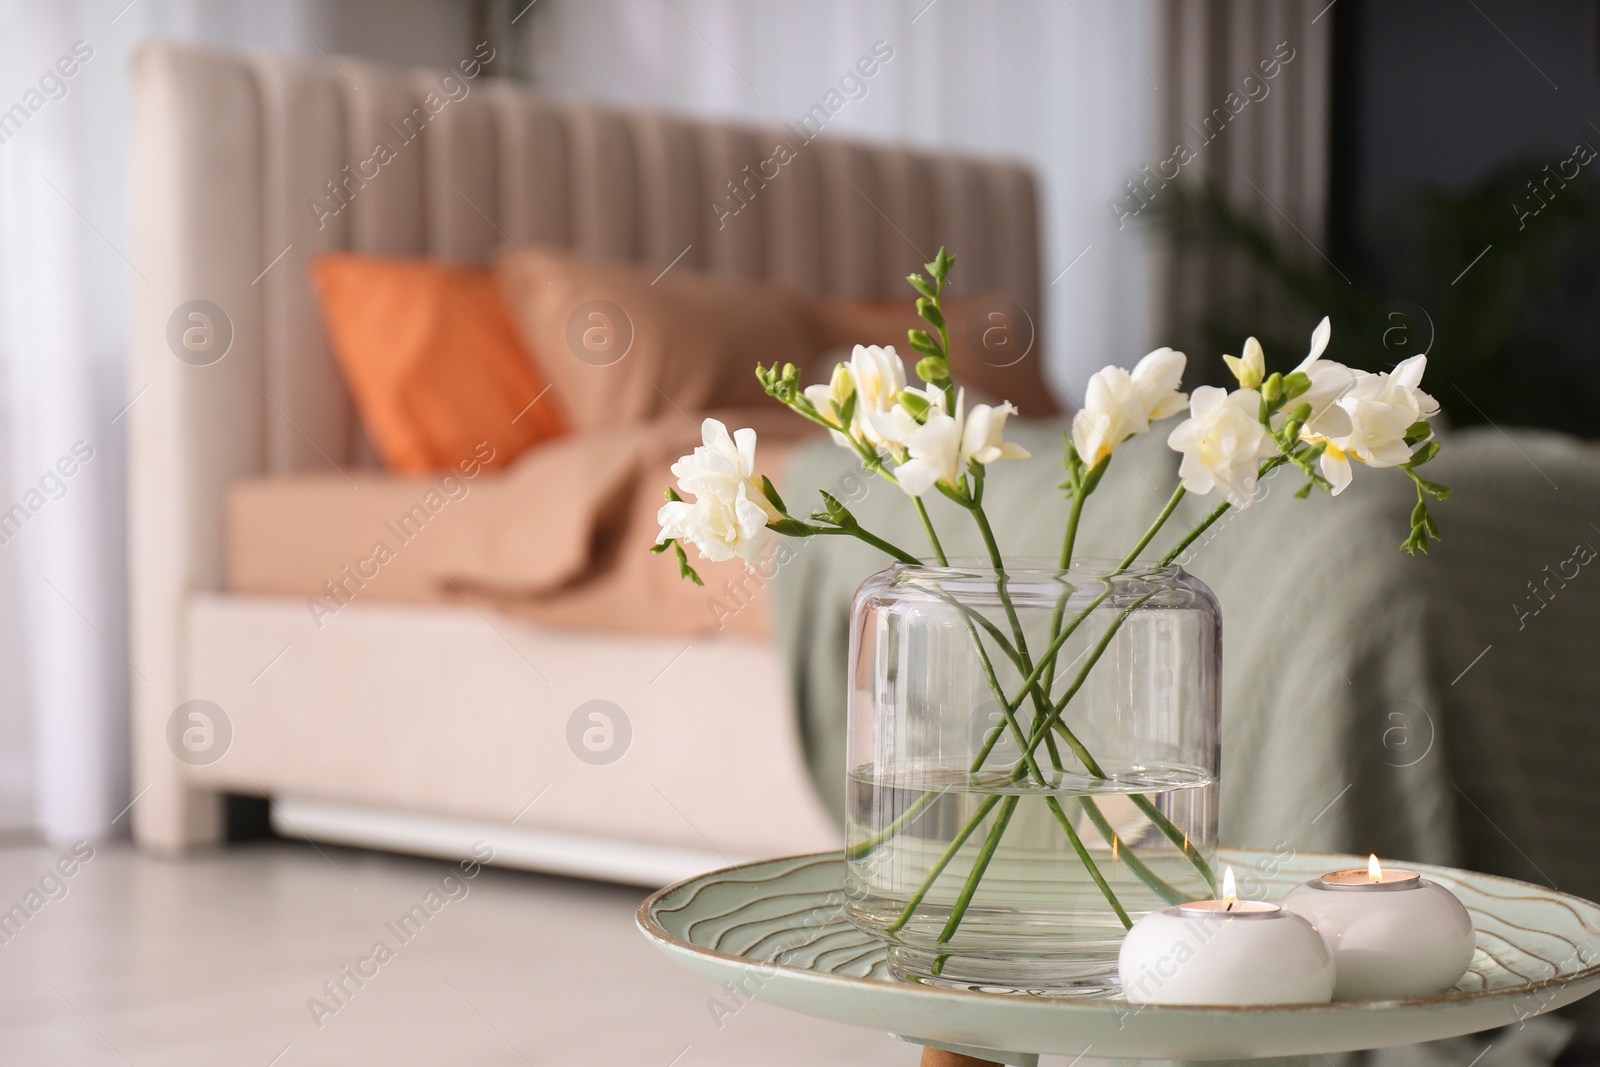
[1117,867,1334,1005]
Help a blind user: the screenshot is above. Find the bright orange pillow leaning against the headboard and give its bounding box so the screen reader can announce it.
[312,253,566,474]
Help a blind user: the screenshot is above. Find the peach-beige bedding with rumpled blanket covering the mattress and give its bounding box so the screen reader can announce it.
[227,405,808,635]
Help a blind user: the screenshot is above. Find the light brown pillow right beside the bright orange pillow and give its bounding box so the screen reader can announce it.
[498,245,826,430]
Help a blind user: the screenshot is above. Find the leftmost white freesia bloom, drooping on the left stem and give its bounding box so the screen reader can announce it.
[656,419,778,563]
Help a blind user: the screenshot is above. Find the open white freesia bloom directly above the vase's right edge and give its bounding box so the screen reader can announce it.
[1166,386,1277,509]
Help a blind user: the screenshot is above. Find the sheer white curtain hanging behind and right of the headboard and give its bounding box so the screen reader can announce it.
[533,0,1166,400]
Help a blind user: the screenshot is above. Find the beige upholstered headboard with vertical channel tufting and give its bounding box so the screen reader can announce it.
[128,37,1040,840]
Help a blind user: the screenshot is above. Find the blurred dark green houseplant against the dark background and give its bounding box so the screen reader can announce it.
[1147,151,1600,438]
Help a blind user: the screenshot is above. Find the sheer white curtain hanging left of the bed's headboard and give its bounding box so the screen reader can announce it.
[0,0,469,840]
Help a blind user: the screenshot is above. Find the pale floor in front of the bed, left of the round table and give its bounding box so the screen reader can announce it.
[0,841,918,1067]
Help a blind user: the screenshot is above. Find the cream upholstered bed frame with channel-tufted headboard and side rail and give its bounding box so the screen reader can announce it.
[128,43,1040,883]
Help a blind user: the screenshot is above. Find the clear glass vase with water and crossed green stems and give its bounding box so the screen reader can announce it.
[846,560,1222,995]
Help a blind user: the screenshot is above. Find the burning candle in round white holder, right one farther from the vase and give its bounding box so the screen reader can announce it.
[1283,856,1477,1000]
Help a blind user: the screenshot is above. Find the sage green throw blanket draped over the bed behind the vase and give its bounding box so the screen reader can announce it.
[773,424,1600,899]
